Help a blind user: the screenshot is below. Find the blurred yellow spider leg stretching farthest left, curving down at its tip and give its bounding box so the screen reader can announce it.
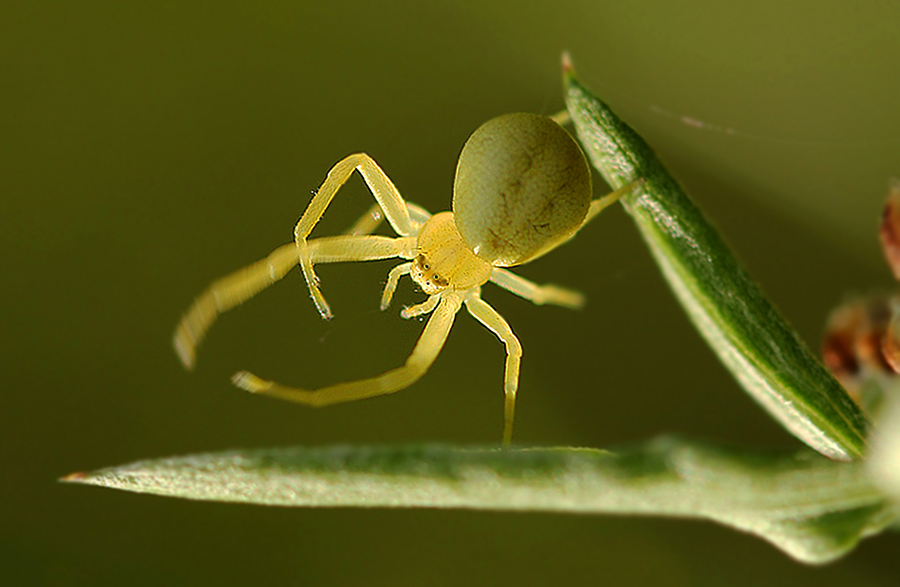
[172,236,415,369]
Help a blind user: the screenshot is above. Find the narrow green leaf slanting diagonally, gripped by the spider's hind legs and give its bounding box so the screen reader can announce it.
[564,62,868,460]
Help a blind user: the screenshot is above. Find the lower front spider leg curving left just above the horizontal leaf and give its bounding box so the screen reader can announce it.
[231,293,463,407]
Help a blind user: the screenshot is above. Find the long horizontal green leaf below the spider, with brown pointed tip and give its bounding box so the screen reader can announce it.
[64,438,897,563]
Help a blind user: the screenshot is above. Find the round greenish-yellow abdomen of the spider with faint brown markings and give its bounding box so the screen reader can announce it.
[453,113,592,267]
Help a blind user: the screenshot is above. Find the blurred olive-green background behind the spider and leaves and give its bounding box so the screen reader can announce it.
[0,0,900,586]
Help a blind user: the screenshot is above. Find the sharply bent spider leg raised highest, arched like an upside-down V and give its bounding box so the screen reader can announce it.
[294,153,414,319]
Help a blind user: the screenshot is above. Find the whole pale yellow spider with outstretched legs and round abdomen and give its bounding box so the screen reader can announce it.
[174,114,633,444]
